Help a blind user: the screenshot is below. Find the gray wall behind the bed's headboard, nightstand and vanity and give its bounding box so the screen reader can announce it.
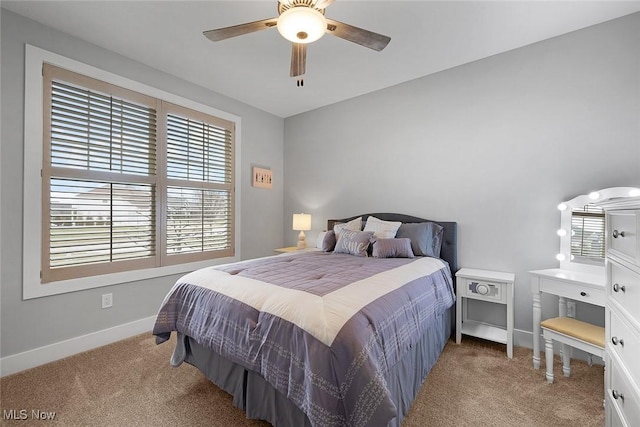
[284,14,640,339]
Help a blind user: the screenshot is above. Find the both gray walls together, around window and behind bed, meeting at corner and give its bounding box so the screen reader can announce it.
[0,10,640,357]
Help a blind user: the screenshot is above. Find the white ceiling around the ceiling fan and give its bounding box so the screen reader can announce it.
[2,0,640,117]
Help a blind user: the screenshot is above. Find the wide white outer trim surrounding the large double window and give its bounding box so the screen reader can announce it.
[22,44,242,300]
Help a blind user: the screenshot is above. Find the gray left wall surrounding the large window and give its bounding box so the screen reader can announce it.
[0,9,284,357]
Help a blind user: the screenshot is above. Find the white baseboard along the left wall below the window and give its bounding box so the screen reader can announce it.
[0,316,156,377]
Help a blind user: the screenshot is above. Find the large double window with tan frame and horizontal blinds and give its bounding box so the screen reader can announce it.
[41,64,235,283]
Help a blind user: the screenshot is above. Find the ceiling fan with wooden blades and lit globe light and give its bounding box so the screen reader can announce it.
[203,0,391,86]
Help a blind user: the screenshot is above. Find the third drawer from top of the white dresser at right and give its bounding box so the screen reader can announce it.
[606,309,640,390]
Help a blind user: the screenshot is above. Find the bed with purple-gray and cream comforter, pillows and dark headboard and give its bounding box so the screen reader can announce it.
[153,213,457,427]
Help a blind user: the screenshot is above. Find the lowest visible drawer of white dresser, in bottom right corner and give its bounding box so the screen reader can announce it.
[607,356,640,426]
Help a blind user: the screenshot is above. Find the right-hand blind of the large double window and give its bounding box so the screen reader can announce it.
[166,105,234,258]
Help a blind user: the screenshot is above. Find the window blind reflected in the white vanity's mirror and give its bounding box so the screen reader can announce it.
[571,204,605,259]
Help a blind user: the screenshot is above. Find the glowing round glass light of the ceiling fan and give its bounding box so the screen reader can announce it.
[278,6,327,43]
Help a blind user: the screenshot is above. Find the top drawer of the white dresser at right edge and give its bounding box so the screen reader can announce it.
[607,211,640,266]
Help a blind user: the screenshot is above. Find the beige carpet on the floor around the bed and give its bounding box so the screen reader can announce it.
[0,335,604,427]
